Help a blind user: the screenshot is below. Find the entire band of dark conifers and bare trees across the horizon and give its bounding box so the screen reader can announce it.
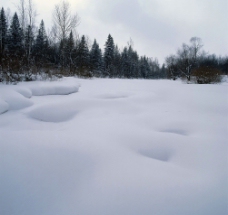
[0,0,228,83]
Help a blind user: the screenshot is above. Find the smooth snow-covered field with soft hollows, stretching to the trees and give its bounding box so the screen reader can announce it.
[0,78,228,215]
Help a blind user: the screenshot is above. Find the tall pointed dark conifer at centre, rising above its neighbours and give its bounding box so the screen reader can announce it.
[104,34,114,77]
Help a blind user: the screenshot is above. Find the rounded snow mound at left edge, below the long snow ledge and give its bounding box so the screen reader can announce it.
[1,89,33,110]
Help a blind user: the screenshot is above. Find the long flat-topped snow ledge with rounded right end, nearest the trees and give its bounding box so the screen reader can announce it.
[29,83,79,96]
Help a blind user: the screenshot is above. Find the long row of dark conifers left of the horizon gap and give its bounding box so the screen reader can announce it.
[0,2,166,82]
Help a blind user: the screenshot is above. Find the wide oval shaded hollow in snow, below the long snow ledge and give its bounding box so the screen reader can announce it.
[28,104,77,122]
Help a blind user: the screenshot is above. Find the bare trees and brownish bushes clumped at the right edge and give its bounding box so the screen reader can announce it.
[166,37,228,84]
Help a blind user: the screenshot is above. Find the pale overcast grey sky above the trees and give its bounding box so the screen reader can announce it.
[0,0,228,63]
